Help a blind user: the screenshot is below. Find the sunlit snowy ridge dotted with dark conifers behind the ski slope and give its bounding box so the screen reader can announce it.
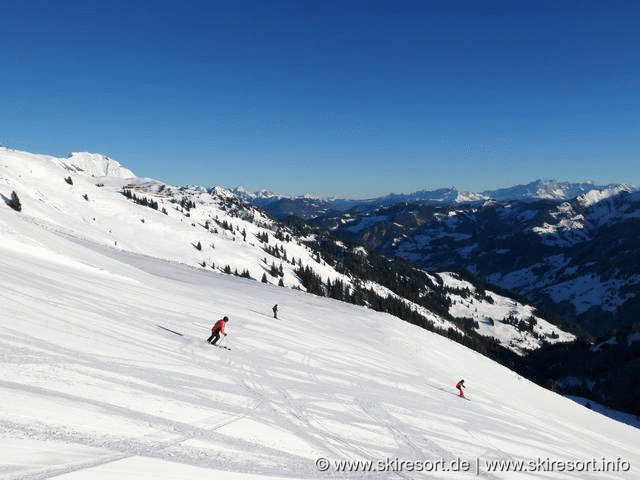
[0,149,574,354]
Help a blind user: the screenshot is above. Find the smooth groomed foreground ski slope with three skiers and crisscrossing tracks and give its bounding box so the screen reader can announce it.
[0,197,640,480]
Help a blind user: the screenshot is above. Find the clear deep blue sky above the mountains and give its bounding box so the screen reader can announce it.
[0,0,640,198]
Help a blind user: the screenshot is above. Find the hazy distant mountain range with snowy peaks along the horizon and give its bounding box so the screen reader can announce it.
[233,180,637,219]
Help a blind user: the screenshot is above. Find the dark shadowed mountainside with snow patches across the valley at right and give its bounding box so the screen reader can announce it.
[314,185,640,335]
